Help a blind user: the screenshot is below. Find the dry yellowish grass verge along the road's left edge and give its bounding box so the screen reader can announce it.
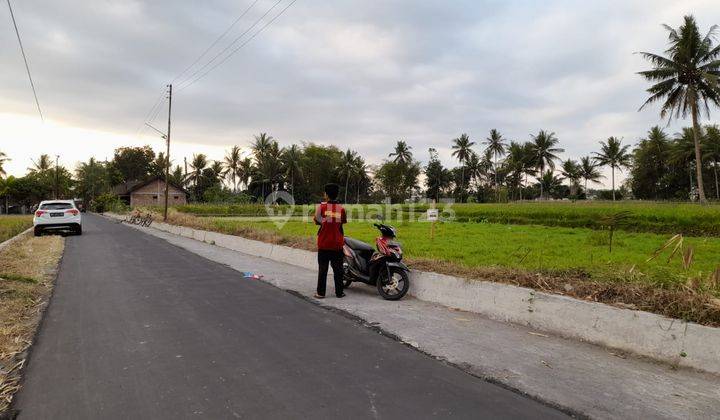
[0,235,64,418]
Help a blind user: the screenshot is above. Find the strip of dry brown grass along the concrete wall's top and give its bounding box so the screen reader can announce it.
[139,211,720,327]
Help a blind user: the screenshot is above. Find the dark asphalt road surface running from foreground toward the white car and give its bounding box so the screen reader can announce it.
[14,215,565,419]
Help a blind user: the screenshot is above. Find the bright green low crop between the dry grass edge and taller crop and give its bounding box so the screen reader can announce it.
[201,217,720,285]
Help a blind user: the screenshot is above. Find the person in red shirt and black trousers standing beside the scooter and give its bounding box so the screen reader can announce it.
[315,184,347,299]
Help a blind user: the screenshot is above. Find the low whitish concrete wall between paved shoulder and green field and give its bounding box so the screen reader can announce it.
[106,214,720,374]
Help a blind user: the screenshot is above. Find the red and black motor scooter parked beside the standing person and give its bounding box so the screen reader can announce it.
[343,223,410,300]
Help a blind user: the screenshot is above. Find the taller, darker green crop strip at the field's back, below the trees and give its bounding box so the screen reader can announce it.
[172,201,720,237]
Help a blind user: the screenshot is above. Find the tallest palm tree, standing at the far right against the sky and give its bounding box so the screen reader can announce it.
[639,15,720,203]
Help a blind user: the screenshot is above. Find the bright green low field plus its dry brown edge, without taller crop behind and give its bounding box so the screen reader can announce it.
[152,211,720,326]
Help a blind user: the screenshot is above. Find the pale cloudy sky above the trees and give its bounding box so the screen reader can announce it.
[0,0,720,187]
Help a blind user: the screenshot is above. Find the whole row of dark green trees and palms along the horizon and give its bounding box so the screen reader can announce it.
[0,16,720,207]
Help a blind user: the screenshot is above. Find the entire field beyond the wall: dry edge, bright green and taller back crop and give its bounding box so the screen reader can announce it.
[148,202,720,326]
